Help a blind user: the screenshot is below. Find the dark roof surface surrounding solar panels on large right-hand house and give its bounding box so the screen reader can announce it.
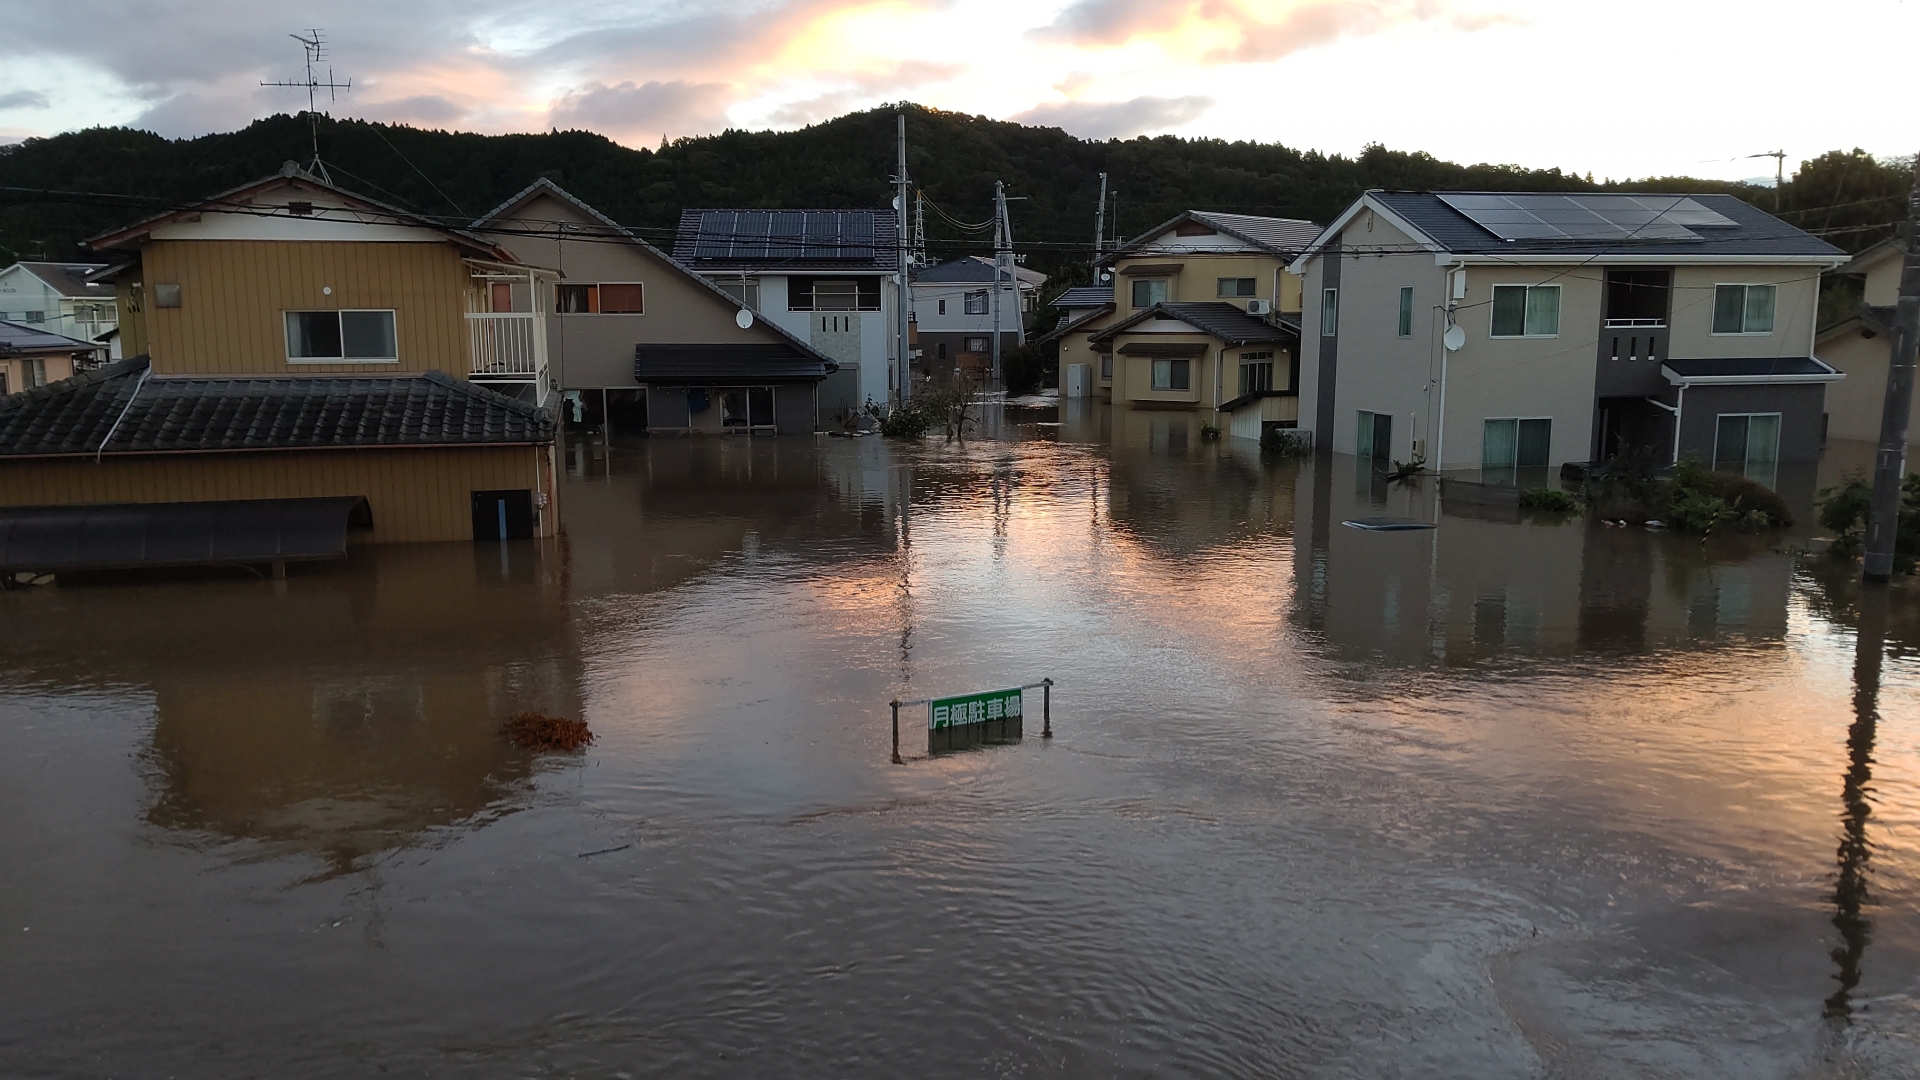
[1369,192,1845,258]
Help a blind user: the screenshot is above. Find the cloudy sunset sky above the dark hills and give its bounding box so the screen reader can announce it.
[0,0,1920,179]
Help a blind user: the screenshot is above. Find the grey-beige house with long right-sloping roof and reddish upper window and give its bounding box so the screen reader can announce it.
[472,179,837,434]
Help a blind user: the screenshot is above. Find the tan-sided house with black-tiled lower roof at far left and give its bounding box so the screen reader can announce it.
[0,161,559,571]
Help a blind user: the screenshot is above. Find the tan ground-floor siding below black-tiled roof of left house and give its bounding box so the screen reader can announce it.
[0,446,557,544]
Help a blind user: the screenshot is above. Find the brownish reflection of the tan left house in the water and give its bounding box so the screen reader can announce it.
[8,544,578,872]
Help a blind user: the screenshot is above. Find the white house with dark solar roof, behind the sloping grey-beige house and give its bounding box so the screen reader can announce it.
[674,209,900,421]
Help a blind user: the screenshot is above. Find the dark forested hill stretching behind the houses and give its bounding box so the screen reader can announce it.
[0,106,1905,284]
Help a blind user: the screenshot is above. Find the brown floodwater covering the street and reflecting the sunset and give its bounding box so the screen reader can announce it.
[0,399,1920,1080]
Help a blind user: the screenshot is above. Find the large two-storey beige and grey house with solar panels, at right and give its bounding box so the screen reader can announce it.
[1294,190,1845,480]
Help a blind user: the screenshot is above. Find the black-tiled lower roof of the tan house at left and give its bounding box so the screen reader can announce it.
[0,356,553,457]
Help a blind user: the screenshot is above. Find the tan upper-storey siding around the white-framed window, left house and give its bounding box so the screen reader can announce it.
[138,240,472,379]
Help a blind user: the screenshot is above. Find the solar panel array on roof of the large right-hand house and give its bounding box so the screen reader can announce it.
[1436,192,1736,240]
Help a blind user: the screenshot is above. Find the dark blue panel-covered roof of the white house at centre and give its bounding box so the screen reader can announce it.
[674,209,900,273]
